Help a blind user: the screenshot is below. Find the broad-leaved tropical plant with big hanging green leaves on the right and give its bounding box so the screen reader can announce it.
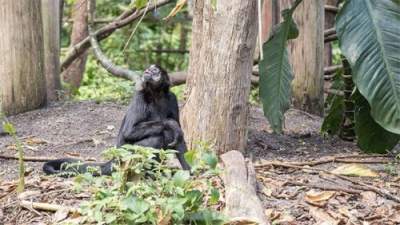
[260,0,400,153]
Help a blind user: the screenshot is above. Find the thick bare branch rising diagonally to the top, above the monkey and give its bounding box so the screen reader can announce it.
[61,0,172,72]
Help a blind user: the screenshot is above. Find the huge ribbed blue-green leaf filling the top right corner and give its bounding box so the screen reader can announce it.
[336,0,400,134]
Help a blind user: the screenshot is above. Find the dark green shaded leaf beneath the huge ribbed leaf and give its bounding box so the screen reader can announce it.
[353,91,400,153]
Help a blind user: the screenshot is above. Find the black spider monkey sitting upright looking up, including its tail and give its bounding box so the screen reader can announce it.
[43,65,190,176]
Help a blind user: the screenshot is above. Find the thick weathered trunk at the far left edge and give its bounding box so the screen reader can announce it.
[0,0,46,115]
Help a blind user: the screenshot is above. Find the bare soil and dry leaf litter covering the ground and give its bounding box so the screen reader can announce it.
[0,102,400,224]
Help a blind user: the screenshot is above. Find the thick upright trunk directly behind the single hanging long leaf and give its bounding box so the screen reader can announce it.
[281,0,325,115]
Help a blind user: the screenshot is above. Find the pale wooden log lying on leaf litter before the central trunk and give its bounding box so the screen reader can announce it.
[221,150,269,225]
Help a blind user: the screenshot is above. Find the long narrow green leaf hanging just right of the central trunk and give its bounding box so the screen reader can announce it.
[259,1,301,133]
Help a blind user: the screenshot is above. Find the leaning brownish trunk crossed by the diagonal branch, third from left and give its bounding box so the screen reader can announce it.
[62,0,89,89]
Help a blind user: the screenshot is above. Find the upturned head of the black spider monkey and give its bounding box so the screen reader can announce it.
[136,65,171,92]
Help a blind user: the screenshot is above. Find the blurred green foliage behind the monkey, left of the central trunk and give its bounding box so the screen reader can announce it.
[61,0,191,101]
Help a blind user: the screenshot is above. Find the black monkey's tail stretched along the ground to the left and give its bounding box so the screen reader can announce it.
[43,158,112,177]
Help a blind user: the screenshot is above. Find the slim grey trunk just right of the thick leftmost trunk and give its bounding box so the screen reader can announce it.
[42,0,61,101]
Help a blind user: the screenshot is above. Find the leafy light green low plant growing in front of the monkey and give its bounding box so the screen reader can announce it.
[67,145,225,225]
